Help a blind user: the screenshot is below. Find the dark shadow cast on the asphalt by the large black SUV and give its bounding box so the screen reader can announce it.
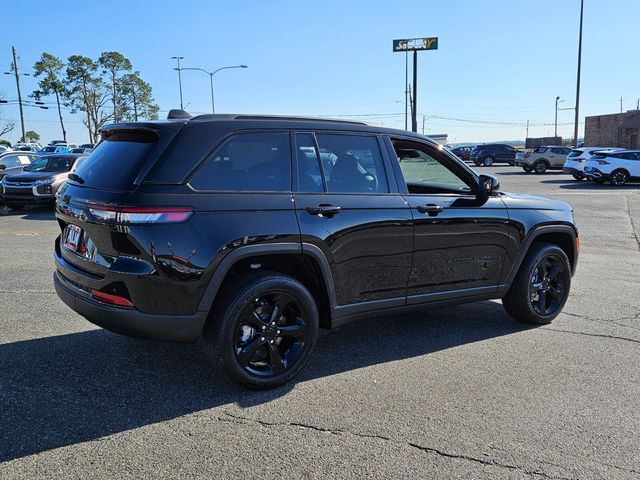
[0,302,528,462]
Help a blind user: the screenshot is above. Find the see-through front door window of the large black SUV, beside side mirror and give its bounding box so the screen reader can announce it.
[393,142,471,193]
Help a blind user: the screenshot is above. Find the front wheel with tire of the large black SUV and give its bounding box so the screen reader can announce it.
[502,243,571,325]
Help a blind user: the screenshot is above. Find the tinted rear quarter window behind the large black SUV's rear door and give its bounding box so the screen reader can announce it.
[189,133,291,192]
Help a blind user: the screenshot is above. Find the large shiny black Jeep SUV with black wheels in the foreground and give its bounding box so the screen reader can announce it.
[54,115,578,388]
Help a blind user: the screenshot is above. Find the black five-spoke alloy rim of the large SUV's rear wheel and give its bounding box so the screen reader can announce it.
[234,292,309,376]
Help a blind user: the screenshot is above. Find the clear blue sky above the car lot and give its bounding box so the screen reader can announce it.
[0,0,640,142]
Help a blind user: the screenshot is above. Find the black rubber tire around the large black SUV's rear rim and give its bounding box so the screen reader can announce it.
[212,276,319,389]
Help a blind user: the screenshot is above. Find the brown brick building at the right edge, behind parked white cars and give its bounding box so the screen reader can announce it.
[584,110,640,149]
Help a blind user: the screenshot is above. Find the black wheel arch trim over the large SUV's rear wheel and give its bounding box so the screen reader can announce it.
[198,243,336,328]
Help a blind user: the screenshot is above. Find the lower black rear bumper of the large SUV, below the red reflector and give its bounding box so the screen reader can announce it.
[53,254,207,342]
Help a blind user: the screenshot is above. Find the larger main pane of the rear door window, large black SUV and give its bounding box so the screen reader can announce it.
[316,134,389,193]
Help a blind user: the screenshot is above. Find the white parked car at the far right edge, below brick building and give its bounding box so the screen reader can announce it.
[584,150,640,185]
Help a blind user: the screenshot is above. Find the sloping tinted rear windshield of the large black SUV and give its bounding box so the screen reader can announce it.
[73,130,158,191]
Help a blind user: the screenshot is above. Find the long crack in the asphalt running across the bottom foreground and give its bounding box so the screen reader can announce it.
[217,411,567,479]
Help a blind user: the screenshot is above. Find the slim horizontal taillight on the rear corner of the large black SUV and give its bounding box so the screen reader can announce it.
[88,204,193,225]
